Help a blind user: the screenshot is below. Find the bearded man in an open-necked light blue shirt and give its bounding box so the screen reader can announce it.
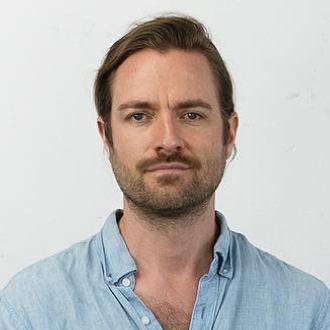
[0,16,330,330]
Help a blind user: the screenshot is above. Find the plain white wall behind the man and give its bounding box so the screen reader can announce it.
[0,0,330,287]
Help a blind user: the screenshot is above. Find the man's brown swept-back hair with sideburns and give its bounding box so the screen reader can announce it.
[94,16,234,143]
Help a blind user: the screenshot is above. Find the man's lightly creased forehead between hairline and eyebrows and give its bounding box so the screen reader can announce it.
[112,49,217,104]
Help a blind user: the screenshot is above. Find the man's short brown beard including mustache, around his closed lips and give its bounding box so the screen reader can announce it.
[110,147,226,226]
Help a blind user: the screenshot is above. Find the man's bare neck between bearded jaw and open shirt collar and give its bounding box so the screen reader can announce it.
[119,196,219,278]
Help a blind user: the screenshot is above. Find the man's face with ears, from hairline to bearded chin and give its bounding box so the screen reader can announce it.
[99,50,237,217]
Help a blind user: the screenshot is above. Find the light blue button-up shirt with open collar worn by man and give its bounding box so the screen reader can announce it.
[0,210,330,330]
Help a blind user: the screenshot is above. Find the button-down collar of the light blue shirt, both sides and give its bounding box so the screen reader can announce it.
[98,209,233,283]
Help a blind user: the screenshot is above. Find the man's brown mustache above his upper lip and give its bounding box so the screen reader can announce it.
[136,153,201,172]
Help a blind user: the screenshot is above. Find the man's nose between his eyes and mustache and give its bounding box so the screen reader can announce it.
[154,115,184,155]
